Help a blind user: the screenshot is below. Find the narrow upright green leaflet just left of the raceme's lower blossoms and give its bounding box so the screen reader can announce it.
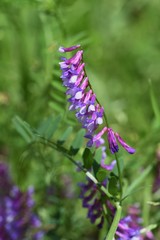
[70,129,85,155]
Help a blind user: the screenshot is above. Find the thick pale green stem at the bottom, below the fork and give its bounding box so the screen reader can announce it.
[104,203,122,240]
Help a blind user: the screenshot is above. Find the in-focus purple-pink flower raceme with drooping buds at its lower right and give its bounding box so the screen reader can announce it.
[59,45,135,163]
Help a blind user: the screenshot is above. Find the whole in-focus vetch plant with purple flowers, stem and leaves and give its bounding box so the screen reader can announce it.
[13,45,159,240]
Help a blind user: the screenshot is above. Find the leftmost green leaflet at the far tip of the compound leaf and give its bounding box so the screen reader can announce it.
[12,116,35,143]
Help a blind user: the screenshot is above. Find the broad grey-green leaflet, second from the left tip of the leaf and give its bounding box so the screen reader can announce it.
[37,115,62,139]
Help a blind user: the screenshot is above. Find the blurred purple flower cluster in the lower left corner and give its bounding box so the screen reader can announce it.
[0,163,43,240]
